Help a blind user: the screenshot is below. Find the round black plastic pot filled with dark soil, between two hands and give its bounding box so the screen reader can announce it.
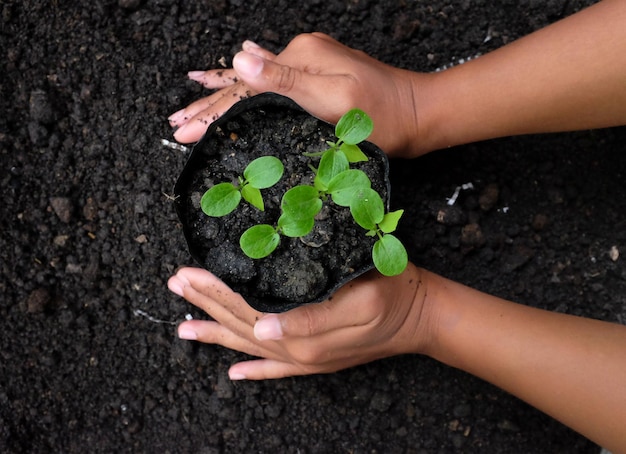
[174,94,389,312]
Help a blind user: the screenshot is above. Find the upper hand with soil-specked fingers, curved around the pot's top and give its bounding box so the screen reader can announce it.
[169,33,427,157]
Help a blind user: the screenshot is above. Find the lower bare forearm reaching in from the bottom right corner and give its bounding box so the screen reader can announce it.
[416,273,626,452]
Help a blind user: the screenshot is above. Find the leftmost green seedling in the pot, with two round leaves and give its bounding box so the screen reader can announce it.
[200,156,284,217]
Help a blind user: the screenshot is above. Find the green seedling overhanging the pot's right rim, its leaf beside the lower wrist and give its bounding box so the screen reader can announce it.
[350,189,408,276]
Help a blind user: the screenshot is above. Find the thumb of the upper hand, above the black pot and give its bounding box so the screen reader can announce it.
[233,51,302,96]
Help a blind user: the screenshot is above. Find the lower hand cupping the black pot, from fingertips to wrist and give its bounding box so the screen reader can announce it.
[168,264,429,380]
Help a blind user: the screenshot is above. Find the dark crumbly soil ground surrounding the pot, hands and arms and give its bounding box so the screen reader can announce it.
[0,0,626,453]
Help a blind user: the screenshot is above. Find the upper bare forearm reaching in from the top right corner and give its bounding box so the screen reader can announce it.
[416,0,626,151]
